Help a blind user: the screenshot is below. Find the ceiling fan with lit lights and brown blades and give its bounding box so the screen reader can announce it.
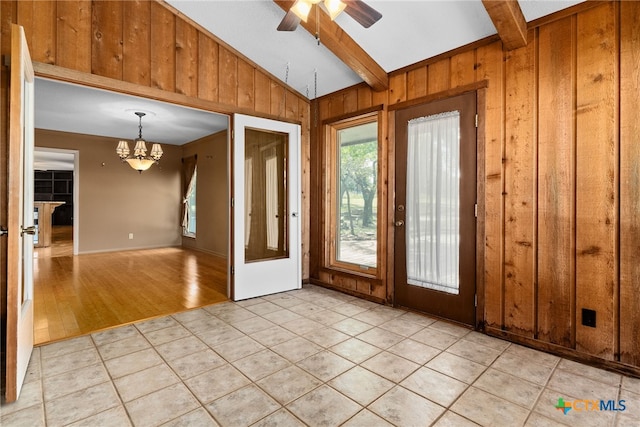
[278,0,382,31]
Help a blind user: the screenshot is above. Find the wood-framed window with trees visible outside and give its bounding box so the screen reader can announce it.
[325,113,379,273]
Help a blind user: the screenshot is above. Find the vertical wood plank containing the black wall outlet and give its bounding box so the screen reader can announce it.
[576,5,620,359]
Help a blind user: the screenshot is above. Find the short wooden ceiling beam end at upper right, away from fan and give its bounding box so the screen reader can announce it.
[482,0,527,50]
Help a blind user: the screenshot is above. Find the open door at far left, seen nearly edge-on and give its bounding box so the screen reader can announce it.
[5,25,35,402]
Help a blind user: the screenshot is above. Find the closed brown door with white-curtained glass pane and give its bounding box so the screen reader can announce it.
[394,93,476,325]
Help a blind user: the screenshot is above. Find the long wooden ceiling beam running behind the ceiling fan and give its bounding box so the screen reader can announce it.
[273,0,389,91]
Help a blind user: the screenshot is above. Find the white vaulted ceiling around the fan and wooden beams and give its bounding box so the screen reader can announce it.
[166,0,581,98]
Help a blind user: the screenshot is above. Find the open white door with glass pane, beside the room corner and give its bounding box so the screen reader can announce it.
[231,114,302,301]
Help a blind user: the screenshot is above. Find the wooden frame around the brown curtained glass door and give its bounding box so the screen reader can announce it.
[386,85,488,330]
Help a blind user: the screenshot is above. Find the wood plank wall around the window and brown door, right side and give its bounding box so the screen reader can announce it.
[311,2,640,372]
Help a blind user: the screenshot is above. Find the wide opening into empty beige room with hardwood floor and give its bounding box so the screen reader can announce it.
[34,78,230,344]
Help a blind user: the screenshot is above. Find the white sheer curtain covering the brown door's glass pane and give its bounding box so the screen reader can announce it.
[406,111,460,294]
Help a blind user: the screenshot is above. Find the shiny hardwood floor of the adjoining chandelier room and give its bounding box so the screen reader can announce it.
[34,227,227,344]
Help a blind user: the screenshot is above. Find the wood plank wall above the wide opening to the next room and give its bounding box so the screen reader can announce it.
[0,0,309,278]
